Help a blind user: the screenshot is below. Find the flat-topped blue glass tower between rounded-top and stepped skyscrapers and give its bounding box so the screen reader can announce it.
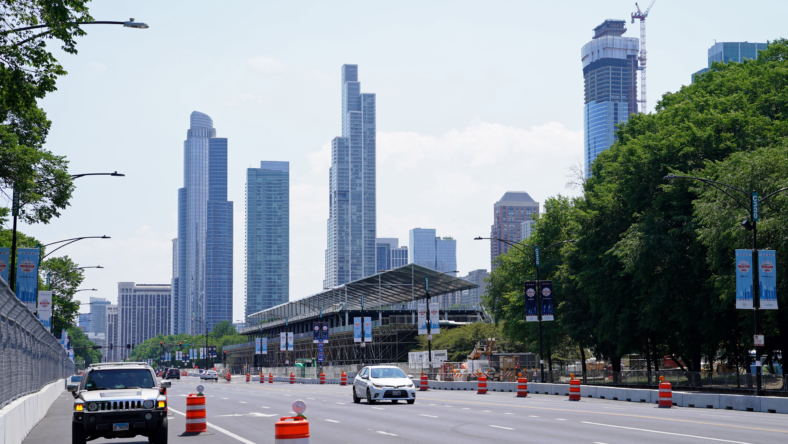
[245,161,290,316]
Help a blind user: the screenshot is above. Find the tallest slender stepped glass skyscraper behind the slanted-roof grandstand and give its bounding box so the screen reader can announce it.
[323,65,376,288]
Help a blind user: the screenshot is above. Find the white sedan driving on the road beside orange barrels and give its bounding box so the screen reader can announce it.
[353,365,416,404]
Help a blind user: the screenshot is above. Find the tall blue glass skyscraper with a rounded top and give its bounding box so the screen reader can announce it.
[172,111,233,334]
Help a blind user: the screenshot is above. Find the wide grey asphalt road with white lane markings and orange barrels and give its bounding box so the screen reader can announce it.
[25,377,788,444]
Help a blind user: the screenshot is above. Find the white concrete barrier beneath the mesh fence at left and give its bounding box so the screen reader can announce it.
[0,379,65,444]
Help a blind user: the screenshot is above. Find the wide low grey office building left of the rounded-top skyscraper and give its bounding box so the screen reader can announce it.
[117,282,172,347]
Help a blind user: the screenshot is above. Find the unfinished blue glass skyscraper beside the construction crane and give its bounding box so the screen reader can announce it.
[581,20,639,177]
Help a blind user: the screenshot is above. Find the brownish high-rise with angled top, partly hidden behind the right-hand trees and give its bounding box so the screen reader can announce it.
[490,191,539,269]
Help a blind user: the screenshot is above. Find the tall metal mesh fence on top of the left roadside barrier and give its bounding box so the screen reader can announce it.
[0,279,75,408]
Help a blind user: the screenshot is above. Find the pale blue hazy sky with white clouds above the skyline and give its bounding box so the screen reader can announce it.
[13,0,788,321]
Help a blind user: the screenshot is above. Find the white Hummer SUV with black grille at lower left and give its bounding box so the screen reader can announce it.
[68,362,171,444]
